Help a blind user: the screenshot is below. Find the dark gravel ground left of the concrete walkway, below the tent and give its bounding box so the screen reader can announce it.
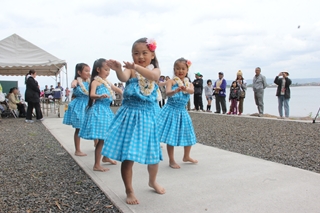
[0,118,120,213]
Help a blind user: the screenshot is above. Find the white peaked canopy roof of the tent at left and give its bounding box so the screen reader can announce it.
[0,34,68,85]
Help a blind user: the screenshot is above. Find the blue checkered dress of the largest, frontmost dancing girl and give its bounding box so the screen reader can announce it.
[102,78,162,164]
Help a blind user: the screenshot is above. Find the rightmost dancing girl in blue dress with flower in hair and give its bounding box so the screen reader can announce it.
[158,58,198,169]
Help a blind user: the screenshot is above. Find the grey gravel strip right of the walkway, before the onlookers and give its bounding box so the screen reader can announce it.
[190,113,320,173]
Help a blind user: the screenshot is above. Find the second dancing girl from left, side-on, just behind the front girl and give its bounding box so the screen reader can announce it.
[79,58,122,172]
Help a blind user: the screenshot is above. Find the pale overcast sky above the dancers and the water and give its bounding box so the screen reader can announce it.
[0,0,320,86]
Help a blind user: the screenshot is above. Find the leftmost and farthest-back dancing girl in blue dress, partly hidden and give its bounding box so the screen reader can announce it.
[63,63,90,156]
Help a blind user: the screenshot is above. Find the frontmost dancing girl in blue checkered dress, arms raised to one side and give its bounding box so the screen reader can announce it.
[102,38,165,204]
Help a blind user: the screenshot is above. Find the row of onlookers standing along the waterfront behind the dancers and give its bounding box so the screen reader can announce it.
[158,67,291,118]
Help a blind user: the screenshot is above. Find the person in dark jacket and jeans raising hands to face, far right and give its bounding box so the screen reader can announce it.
[274,72,291,119]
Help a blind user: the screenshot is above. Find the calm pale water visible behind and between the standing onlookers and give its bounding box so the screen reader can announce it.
[191,86,320,117]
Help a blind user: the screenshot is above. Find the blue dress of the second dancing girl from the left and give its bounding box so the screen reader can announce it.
[79,84,114,140]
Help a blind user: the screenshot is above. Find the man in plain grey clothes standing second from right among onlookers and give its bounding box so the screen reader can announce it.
[252,67,268,117]
